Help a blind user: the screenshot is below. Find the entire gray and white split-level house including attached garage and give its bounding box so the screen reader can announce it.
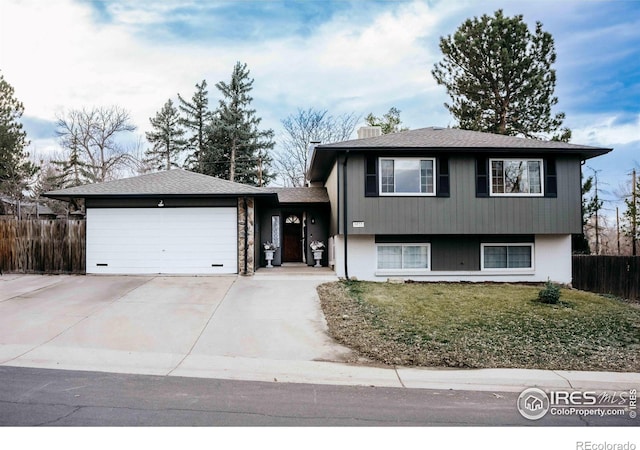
[46,128,611,283]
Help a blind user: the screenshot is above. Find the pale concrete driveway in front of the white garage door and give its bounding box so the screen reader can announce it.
[0,275,349,375]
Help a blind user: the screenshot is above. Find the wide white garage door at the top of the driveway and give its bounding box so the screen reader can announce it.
[87,208,238,274]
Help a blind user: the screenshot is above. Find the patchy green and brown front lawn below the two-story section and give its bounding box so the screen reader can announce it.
[318,282,640,372]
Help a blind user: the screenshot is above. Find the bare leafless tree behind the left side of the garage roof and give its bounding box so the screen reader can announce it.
[57,106,136,182]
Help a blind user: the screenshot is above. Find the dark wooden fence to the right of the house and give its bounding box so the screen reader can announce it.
[572,255,640,300]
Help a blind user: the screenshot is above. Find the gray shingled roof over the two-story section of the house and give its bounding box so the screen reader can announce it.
[309,127,612,181]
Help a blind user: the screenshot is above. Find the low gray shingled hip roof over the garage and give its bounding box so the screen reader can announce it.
[43,169,273,199]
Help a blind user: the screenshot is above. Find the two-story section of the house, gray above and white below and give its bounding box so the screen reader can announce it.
[309,127,611,283]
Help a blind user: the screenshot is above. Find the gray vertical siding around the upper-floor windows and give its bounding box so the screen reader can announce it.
[348,155,582,235]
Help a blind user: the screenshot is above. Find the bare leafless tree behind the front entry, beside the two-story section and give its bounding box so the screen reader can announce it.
[276,108,360,187]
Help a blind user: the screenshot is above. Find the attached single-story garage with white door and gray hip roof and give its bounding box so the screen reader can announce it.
[45,169,268,275]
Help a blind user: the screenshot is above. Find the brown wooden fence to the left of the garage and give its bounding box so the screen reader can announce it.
[0,219,86,273]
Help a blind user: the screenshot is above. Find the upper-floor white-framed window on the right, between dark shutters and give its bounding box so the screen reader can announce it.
[489,159,544,197]
